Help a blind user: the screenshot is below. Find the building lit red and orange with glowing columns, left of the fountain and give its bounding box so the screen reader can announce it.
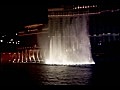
[0,24,47,63]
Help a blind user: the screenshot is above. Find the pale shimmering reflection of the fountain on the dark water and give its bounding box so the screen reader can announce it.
[31,65,91,85]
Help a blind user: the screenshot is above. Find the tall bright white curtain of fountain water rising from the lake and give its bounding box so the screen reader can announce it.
[45,15,94,65]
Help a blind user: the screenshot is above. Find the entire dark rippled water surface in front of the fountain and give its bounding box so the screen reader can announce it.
[0,64,119,86]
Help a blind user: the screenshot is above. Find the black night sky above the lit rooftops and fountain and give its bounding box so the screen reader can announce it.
[0,0,120,32]
